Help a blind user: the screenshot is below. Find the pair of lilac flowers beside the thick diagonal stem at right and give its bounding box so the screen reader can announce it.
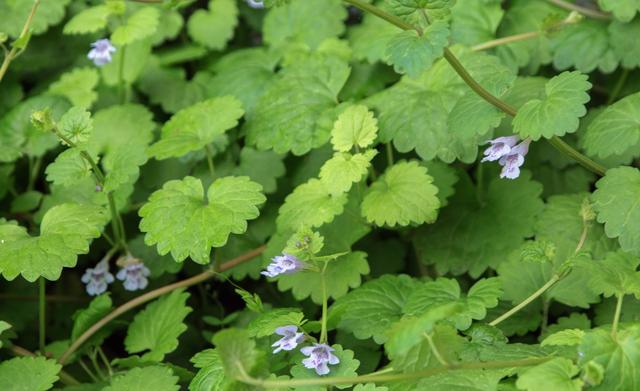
[482,136,531,179]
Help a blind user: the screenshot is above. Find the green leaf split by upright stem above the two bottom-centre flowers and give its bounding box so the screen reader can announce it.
[278,251,369,304]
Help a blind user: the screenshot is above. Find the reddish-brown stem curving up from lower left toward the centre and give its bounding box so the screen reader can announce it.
[58,245,266,365]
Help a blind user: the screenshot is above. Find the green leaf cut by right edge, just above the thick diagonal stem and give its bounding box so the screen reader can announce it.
[583,93,640,158]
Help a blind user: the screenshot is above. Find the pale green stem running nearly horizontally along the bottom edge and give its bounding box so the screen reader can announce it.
[236,357,551,388]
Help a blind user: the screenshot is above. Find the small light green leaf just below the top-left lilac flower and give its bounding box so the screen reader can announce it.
[49,68,98,109]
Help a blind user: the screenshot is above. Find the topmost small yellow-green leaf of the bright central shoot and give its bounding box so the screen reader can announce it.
[331,105,378,152]
